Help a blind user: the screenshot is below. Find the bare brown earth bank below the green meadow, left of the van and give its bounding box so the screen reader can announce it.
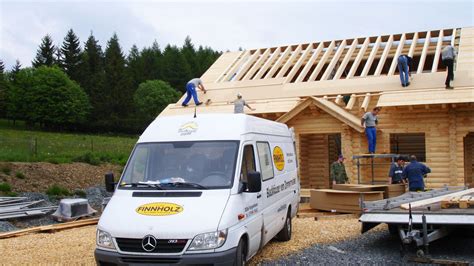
[0,162,122,193]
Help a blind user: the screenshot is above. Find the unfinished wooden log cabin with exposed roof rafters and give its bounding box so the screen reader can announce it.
[160,27,474,188]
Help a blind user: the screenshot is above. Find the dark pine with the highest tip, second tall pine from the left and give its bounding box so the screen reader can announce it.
[61,29,81,81]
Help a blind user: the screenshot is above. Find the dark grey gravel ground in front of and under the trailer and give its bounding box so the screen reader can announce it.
[263,230,474,265]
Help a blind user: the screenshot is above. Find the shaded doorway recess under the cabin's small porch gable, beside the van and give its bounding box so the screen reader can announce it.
[299,133,341,188]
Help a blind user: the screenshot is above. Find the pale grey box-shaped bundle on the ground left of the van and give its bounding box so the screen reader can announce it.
[52,199,97,221]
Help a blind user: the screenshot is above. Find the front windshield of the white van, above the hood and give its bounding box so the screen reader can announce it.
[120,141,239,189]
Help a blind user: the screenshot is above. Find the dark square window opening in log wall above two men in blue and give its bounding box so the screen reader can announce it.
[390,133,426,162]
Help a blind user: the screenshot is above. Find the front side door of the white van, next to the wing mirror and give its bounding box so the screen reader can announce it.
[240,142,263,256]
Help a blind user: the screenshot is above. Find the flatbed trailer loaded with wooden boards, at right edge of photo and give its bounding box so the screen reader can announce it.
[359,187,474,257]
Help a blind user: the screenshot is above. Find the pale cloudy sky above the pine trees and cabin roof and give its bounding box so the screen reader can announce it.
[0,0,474,69]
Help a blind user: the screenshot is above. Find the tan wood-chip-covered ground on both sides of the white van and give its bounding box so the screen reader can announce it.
[0,218,370,265]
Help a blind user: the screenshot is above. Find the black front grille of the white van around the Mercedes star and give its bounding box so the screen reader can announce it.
[115,238,188,253]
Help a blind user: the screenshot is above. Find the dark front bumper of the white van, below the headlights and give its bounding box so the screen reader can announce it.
[94,248,236,265]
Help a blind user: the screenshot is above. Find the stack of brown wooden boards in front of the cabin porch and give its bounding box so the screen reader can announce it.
[309,189,384,213]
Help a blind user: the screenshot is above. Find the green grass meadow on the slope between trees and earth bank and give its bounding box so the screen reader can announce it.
[0,120,137,165]
